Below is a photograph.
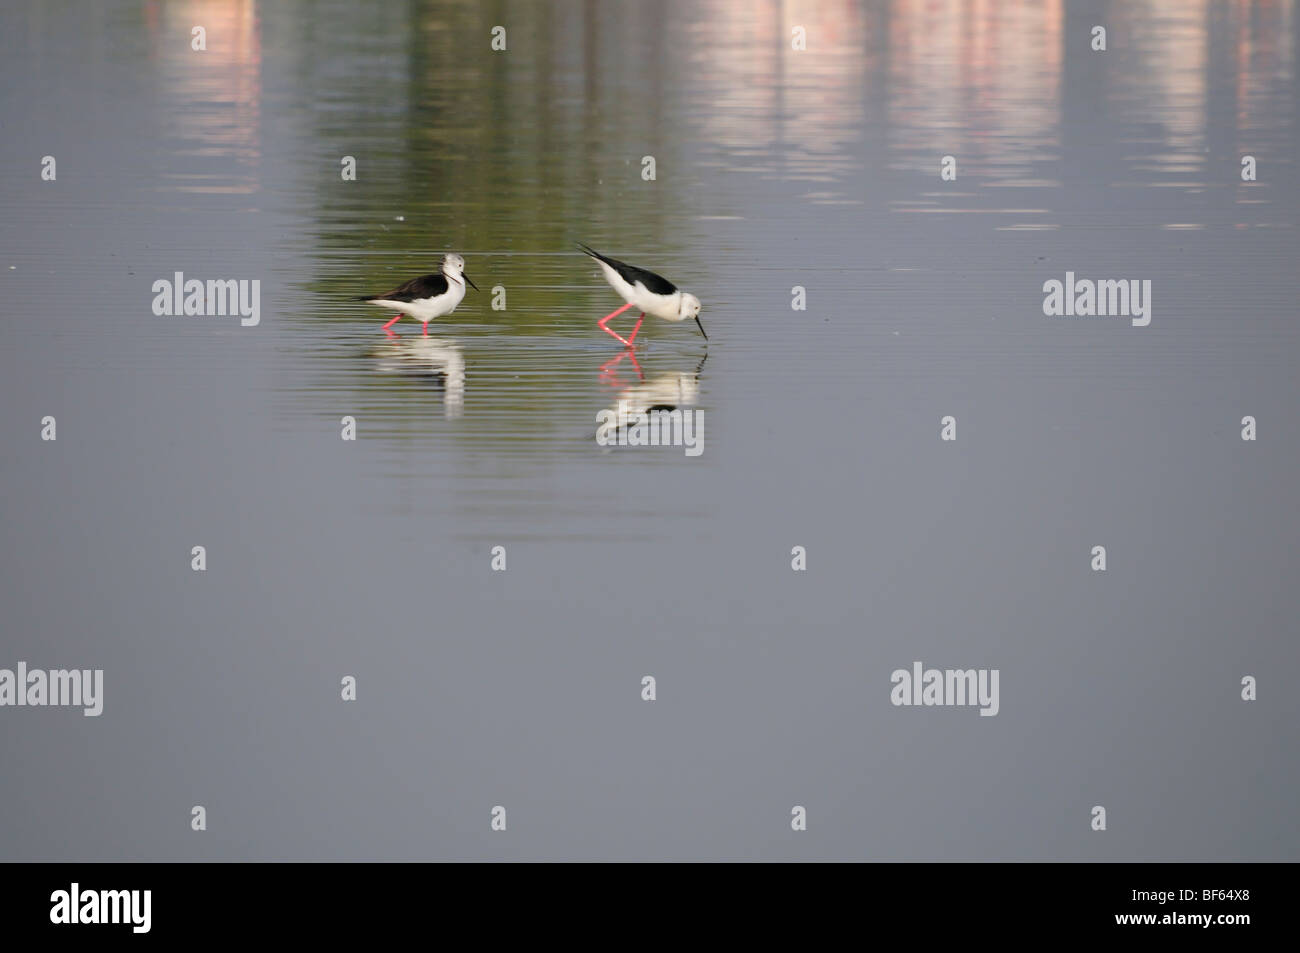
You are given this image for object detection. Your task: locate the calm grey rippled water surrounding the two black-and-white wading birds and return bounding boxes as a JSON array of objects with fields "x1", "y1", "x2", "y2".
[{"x1": 0, "y1": 0, "x2": 1300, "y2": 861}]
